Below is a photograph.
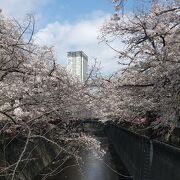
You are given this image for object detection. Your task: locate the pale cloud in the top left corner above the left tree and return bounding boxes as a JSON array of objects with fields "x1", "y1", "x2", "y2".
[{"x1": 0, "y1": 0, "x2": 50, "y2": 18}]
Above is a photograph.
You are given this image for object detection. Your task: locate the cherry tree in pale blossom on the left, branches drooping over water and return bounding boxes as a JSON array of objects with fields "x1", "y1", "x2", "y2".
[{"x1": 0, "y1": 15, "x2": 103, "y2": 180}]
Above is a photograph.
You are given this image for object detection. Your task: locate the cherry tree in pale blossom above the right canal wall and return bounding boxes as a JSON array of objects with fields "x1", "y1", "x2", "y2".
[{"x1": 97, "y1": 1, "x2": 180, "y2": 136}]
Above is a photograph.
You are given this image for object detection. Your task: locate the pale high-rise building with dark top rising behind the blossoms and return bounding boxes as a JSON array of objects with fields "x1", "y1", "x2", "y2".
[{"x1": 67, "y1": 51, "x2": 88, "y2": 82}]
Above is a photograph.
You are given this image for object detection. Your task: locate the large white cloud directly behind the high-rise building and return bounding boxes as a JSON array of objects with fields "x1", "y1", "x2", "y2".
[{"x1": 35, "y1": 12, "x2": 123, "y2": 73}]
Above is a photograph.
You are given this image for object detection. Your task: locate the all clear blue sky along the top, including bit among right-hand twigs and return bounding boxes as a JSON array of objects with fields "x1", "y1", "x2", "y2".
[{"x1": 33, "y1": 0, "x2": 140, "y2": 27}]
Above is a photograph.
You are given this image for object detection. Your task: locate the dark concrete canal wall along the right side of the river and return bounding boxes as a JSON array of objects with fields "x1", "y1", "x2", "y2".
[{"x1": 105, "y1": 124, "x2": 180, "y2": 180}]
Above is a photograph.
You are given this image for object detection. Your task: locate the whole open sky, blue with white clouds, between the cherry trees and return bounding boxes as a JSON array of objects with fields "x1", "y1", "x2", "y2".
[{"x1": 0, "y1": 0, "x2": 144, "y2": 74}]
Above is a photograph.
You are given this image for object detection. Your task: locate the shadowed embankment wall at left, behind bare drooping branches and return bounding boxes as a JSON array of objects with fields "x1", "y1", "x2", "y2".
[{"x1": 0, "y1": 137, "x2": 60, "y2": 180}]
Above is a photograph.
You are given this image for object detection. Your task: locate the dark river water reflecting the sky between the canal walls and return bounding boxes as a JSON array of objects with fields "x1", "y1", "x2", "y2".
[{"x1": 35, "y1": 125, "x2": 131, "y2": 180}]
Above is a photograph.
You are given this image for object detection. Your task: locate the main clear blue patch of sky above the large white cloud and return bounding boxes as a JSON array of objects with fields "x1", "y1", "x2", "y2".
[{"x1": 40, "y1": 0, "x2": 113, "y2": 22}]
